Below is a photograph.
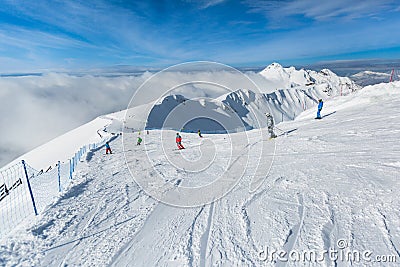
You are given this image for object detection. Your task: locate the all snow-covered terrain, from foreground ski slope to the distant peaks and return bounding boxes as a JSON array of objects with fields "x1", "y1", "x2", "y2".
[{"x1": 0, "y1": 63, "x2": 400, "y2": 266}]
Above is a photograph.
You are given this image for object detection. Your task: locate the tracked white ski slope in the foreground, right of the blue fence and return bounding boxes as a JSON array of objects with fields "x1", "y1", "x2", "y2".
[{"x1": 0, "y1": 82, "x2": 400, "y2": 266}]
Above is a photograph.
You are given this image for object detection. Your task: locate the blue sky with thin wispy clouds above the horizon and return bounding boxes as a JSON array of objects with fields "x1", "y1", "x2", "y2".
[{"x1": 0, "y1": 0, "x2": 400, "y2": 73}]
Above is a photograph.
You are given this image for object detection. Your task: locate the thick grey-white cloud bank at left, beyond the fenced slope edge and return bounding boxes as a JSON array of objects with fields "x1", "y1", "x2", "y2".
[{"x1": 0, "y1": 74, "x2": 140, "y2": 168}]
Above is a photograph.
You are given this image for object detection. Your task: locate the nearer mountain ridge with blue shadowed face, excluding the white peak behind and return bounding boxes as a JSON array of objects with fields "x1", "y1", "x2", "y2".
[{"x1": 120, "y1": 88, "x2": 326, "y2": 133}]
